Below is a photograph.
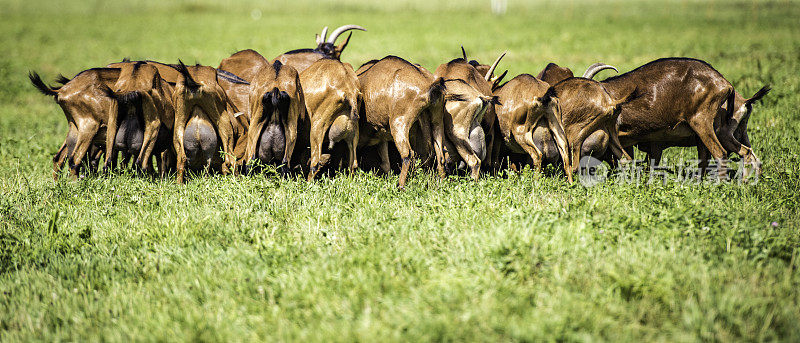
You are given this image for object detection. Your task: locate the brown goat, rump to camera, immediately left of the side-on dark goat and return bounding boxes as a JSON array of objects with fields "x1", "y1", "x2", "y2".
[{"x1": 542, "y1": 77, "x2": 632, "y2": 172}]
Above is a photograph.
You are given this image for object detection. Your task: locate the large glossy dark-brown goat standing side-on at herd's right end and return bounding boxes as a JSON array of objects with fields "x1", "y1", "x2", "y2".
[{"x1": 603, "y1": 58, "x2": 769, "y2": 175}]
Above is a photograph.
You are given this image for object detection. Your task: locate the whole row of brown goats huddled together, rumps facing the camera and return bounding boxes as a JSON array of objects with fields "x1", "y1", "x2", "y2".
[{"x1": 29, "y1": 25, "x2": 769, "y2": 188}]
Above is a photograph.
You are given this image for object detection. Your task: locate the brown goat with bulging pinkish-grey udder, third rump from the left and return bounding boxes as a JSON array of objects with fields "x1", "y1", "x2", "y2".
[{"x1": 173, "y1": 62, "x2": 240, "y2": 183}]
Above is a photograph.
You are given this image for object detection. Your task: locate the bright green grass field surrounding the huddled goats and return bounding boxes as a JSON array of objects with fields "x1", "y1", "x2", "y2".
[{"x1": 0, "y1": 0, "x2": 800, "y2": 341}]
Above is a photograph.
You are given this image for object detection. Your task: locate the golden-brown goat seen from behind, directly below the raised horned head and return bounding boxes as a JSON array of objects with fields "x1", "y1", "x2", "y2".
[{"x1": 300, "y1": 58, "x2": 361, "y2": 181}]
